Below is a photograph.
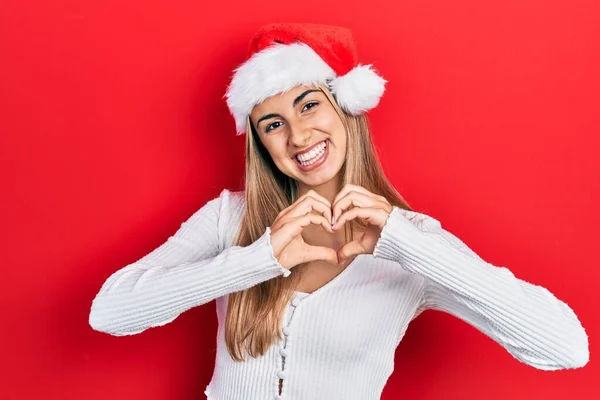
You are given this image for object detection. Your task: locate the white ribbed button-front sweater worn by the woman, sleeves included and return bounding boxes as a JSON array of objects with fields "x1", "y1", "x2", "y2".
[{"x1": 89, "y1": 189, "x2": 589, "y2": 400}]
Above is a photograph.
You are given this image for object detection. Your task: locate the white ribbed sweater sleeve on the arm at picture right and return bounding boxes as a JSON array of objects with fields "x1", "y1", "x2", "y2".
[{"x1": 373, "y1": 206, "x2": 589, "y2": 371}]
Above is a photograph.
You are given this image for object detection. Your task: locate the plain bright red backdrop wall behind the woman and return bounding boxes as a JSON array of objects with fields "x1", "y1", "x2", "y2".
[{"x1": 0, "y1": 0, "x2": 600, "y2": 400}]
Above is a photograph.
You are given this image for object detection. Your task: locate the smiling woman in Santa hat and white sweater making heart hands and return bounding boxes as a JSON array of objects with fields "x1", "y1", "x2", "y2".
[{"x1": 89, "y1": 24, "x2": 589, "y2": 400}]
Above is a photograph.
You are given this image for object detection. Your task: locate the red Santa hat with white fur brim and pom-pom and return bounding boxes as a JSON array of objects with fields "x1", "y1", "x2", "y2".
[{"x1": 224, "y1": 23, "x2": 387, "y2": 135}]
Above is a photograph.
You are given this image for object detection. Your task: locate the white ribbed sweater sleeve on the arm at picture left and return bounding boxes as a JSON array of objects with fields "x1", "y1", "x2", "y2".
[{"x1": 89, "y1": 190, "x2": 291, "y2": 336}]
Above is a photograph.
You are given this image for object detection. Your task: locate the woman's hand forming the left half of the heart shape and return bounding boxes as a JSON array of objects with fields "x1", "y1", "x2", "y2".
[{"x1": 271, "y1": 190, "x2": 338, "y2": 269}]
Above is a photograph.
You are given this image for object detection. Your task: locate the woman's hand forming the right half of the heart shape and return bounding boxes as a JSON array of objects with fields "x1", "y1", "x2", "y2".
[{"x1": 332, "y1": 184, "x2": 394, "y2": 264}]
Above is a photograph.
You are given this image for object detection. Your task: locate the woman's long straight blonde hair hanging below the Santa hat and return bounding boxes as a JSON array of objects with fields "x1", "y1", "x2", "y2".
[{"x1": 225, "y1": 85, "x2": 412, "y2": 361}]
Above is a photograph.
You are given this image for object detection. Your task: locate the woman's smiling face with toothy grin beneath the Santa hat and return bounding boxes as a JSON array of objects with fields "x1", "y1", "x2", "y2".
[{"x1": 250, "y1": 86, "x2": 346, "y2": 189}]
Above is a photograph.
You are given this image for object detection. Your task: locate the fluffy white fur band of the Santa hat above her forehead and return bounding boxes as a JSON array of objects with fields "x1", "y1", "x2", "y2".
[{"x1": 225, "y1": 42, "x2": 336, "y2": 135}]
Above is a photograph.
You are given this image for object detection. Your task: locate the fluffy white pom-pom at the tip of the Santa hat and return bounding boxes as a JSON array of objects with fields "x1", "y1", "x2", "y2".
[{"x1": 329, "y1": 64, "x2": 387, "y2": 115}]
